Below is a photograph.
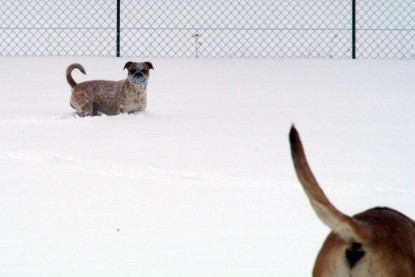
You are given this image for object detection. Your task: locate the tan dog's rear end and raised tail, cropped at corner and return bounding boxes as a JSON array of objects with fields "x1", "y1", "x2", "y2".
[{"x1": 290, "y1": 127, "x2": 415, "y2": 277}]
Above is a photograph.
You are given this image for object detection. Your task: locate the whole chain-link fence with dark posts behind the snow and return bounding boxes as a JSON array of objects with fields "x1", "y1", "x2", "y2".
[{"x1": 0, "y1": 0, "x2": 415, "y2": 59}]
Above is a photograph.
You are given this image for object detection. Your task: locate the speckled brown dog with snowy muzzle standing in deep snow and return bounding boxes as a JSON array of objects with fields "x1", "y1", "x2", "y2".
[{"x1": 66, "y1": 62, "x2": 154, "y2": 117}]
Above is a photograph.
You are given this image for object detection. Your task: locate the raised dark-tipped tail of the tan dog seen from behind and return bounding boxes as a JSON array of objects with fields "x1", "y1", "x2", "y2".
[{"x1": 290, "y1": 126, "x2": 373, "y2": 243}]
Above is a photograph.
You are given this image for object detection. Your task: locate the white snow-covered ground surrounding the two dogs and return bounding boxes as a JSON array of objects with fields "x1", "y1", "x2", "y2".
[{"x1": 0, "y1": 57, "x2": 415, "y2": 276}]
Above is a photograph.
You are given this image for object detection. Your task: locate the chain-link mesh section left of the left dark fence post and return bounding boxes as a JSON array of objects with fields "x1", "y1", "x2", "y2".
[{"x1": 0, "y1": 0, "x2": 117, "y2": 56}]
